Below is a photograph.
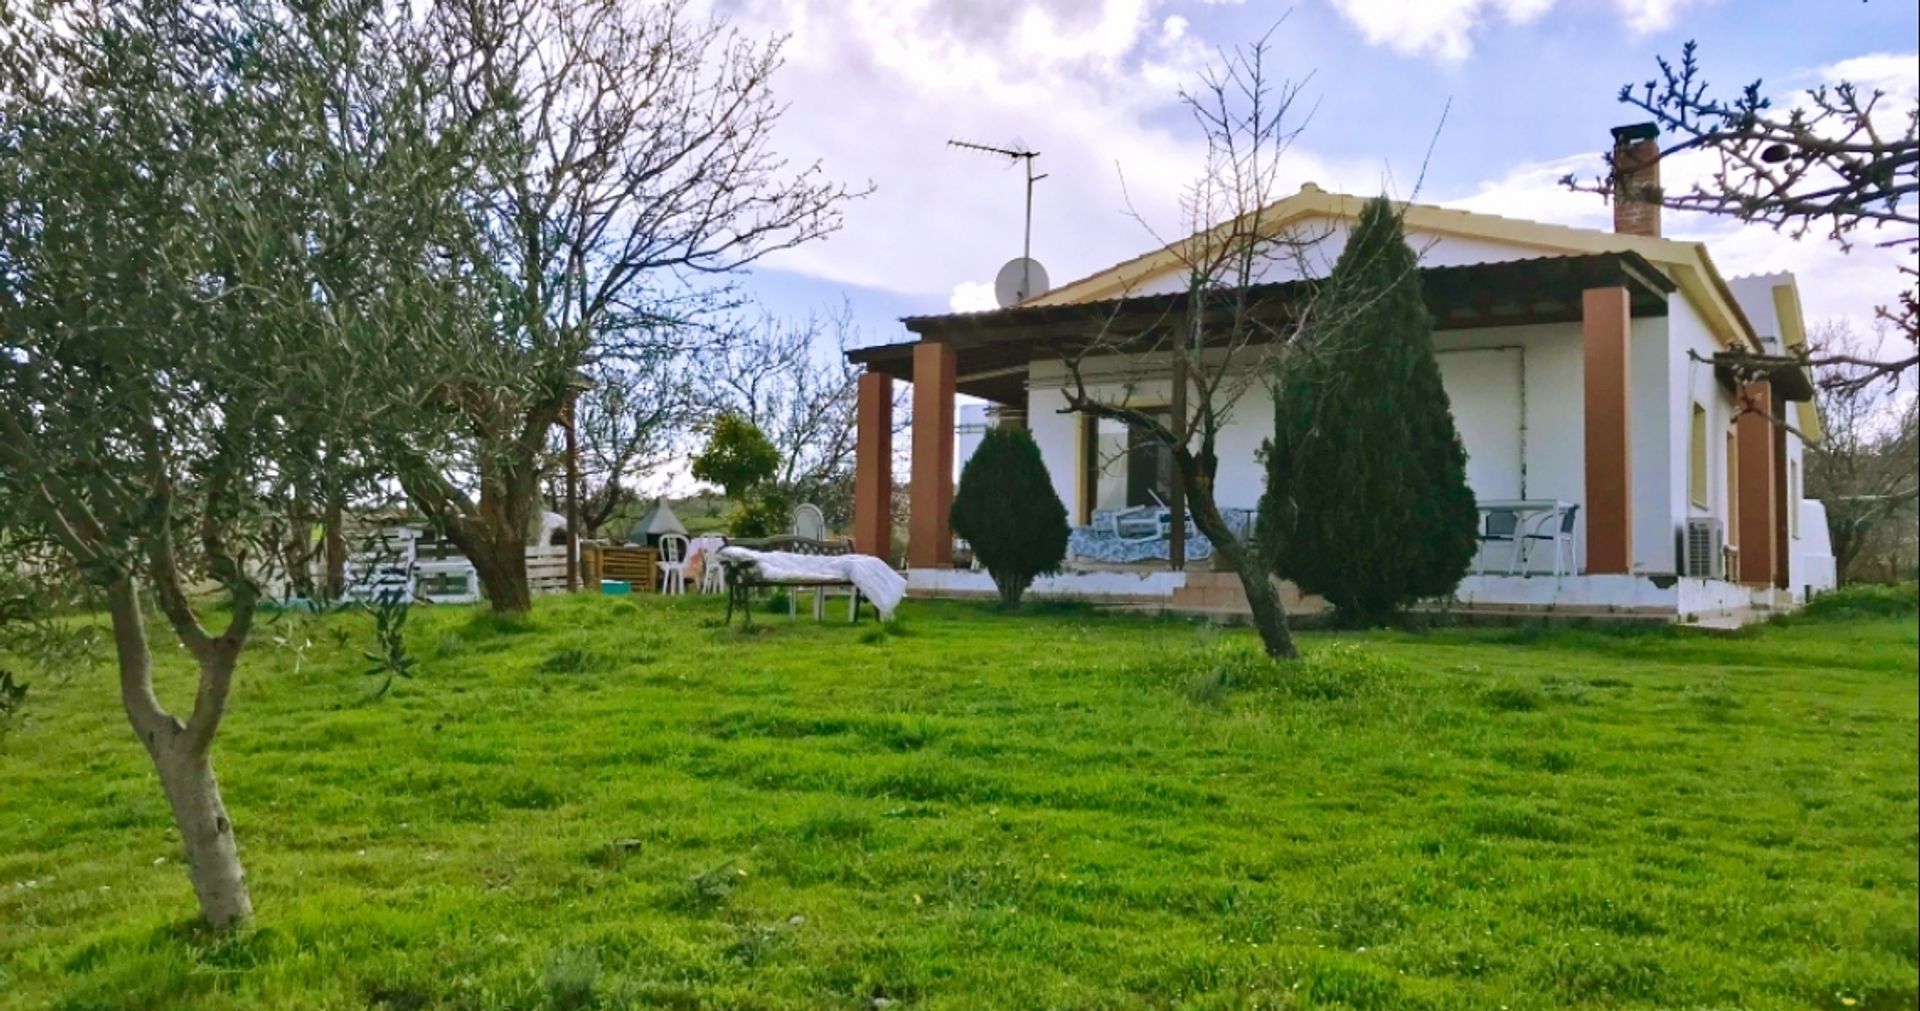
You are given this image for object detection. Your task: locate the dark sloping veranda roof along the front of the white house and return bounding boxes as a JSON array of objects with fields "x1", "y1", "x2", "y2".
[{"x1": 847, "y1": 251, "x2": 1674, "y2": 405}]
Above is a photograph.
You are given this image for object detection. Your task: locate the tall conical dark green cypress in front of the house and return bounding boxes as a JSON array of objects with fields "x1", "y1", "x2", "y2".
[{"x1": 1260, "y1": 198, "x2": 1478, "y2": 625}]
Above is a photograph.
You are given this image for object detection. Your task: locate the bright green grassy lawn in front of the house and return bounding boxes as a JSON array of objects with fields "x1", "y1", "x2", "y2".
[{"x1": 0, "y1": 597, "x2": 1920, "y2": 1011}]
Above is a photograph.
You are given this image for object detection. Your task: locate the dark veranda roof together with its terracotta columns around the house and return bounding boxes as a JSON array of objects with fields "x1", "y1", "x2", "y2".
[{"x1": 847, "y1": 251, "x2": 1784, "y2": 613}]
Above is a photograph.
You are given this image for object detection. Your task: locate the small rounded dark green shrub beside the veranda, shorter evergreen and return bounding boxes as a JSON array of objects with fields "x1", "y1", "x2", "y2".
[{"x1": 952, "y1": 428, "x2": 1068, "y2": 608}]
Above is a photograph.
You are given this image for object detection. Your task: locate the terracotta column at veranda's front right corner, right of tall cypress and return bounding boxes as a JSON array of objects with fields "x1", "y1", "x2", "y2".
[{"x1": 1580, "y1": 288, "x2": 1634, "y2": 574}]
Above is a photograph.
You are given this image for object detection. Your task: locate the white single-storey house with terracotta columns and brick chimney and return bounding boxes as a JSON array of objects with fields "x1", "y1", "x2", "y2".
[{"x1": 849, "y1": 127, "x2": 1834, "y2": 620}]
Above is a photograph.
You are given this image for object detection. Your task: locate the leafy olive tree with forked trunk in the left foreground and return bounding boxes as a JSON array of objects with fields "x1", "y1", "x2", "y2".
[{"x1": 0, "y1": 0, "x2": 460, "y2": 927}]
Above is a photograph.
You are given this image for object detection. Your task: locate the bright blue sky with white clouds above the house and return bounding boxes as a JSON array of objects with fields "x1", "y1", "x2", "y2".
[{"x1": 714, "y1": 0, "x2": 1920, "y2": 352}]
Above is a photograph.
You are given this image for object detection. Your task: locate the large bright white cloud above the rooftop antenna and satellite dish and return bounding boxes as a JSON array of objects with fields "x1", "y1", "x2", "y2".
[{"x1": 724, "y1": 0, "x2": 1379, "y2": 307}]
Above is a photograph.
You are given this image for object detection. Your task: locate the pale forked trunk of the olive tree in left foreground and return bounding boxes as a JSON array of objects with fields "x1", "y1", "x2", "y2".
[{"x1": 108, "y1": 577, "x2": 253, "y2": 929}]
